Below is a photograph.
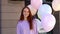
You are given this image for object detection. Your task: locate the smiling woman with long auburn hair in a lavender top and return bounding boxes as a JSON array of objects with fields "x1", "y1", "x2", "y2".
[{"x1": 17, "y1": 7, "x2": 38, "y2": 34}]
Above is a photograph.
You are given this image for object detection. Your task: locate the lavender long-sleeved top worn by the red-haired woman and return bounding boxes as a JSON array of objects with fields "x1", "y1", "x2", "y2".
[{"x1": 17, "y1": 20, "x2": 38, "y2": 34}]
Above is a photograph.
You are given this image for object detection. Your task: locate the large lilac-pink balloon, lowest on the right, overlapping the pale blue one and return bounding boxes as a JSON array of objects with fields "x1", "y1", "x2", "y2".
[{"x1": 41, "y1": 14, "x2": 56, "y2": 32}]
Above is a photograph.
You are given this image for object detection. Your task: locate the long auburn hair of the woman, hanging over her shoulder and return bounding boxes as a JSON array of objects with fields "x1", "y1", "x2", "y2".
[{"x1": 19, "y1": 7, "x2": 33, "y2": 30}]
